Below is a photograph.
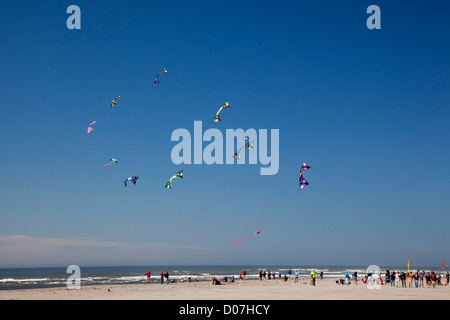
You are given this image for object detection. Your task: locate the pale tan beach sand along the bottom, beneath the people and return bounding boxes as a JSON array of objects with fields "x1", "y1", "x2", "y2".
[{"x1": 0, "y1": 279, "x2": 450, "y2": 300}]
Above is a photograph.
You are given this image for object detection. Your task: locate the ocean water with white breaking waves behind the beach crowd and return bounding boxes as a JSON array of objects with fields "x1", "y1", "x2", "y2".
[{"x1": 0, "y1": 265, "x2": 442, "y2": 290}]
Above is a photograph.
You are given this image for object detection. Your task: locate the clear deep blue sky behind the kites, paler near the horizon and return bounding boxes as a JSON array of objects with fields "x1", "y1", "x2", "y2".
[{"x1": 0, "y1": 0, "x2": 450, "y2": 267}]
